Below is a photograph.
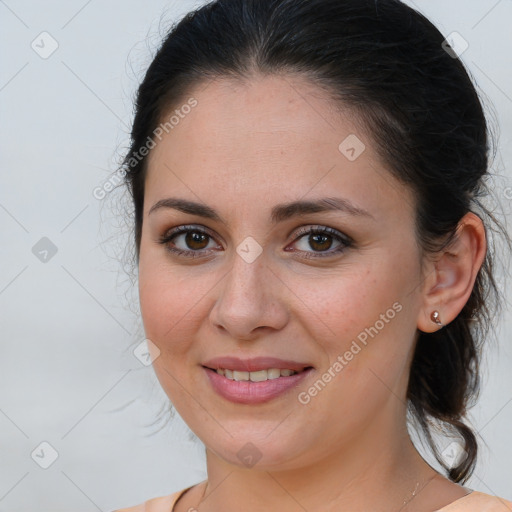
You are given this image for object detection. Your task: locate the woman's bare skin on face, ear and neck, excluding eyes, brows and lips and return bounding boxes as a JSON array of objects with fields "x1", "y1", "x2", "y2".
[{"x1": 135, "y1": 76, "x2": 486, "y2": 512}]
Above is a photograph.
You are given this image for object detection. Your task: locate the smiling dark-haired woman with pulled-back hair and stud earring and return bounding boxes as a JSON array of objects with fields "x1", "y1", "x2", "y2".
[{"x1": 114, "y1": 0, "x2": 512, "y2": 512}]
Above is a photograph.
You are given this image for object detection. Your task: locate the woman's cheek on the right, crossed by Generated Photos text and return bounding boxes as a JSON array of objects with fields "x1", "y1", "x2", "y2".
[{"x1": 303, "y1": 259, "x2": 415, "y2": 386}]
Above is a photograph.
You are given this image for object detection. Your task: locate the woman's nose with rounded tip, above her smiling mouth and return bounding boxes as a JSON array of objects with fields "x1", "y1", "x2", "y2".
[{"x1": 210, "y1": 248, "x2": 290, "y2": 341}]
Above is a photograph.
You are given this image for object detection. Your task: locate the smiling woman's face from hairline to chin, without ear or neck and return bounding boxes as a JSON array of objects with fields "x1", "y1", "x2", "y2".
[{"x1": 139, "y1": 77, "x2": 422, "y2": 468}]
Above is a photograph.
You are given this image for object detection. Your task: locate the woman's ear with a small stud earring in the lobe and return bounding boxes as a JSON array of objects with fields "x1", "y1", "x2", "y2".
[{"x1": 418, "y1": 212, "x2": 487, "y2": 332}]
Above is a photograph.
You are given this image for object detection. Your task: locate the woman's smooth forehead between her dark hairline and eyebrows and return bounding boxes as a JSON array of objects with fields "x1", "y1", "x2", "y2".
[{"x1": 146, "y1": 76, "x2": 412, "y2": 222}]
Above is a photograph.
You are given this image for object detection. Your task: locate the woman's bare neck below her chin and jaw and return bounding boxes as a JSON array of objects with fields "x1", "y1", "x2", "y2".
[{"x1": 201, "y1": 408, "x2": 436, "y2": 512}]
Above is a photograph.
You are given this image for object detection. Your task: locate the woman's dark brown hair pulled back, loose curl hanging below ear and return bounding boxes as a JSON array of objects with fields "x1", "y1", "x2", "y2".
[{"x1": 123, "y1": 0, "x2": 510, "y2": 482}]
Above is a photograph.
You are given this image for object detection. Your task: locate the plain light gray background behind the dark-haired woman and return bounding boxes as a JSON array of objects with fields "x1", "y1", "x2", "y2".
[{"x1": 0, "y1": 0, "x2": 512, "y2": 512}]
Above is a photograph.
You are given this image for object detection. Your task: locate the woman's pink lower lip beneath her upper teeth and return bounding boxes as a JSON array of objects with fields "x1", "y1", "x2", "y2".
[{"x1": 203, "y1": 366, "x2": 313, "y2": 404}]
